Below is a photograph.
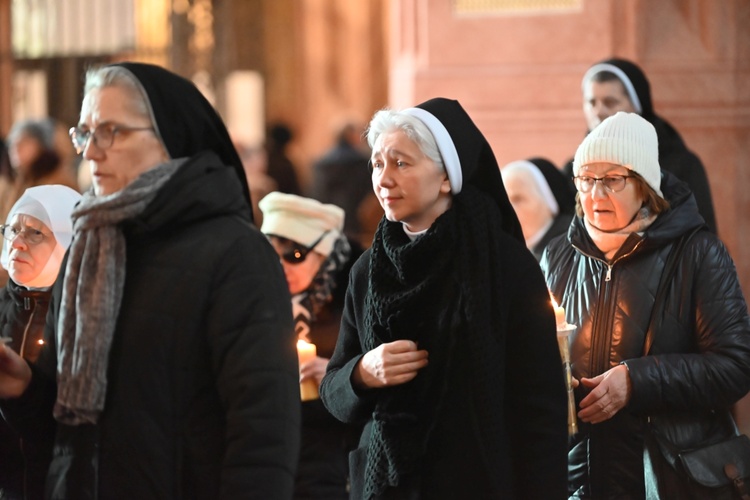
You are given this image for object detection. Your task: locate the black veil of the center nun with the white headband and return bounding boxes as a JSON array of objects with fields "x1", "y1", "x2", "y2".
[{"x1": 415, "y1": 97, "x2": 524, "y2": 242}]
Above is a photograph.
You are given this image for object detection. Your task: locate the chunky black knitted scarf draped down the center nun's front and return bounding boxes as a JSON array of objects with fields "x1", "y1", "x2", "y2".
[{"x1": 364, "y1": 186, "x2": 504, "y2": 499}]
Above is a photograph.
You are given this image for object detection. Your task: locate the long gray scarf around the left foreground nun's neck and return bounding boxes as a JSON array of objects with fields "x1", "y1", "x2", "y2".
[{"x1": 53, "y1": 158, "x2": 185, "y2": 425}]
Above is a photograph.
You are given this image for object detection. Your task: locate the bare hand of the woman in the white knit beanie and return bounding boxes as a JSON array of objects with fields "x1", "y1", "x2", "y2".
[{"x1": 578, "y1": 365, "x2": 630, "y2": 424}]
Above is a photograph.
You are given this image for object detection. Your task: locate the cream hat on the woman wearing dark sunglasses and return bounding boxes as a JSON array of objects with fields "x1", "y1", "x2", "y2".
[{"x1": 258, "y1": 191, "x2": 344, "y2": 257}]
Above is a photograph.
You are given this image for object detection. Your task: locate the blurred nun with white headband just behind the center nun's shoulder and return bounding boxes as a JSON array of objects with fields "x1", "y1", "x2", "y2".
[{"x1": 500, "y1": 158, "x2": 575, "y2": 260}]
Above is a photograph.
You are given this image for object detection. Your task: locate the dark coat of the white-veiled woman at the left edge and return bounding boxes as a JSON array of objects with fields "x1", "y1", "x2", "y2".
[{"x1": 0, "y1": 280, "x2": 52, "y2": 500}]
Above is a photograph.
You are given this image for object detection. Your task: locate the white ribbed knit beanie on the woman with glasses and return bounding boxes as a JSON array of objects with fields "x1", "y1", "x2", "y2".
[{"x1": 573, "y1": 111, "x2": 664, "y2": 198}]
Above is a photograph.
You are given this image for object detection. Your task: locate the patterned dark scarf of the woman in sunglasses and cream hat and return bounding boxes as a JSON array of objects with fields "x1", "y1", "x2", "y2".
[{"x1": 292, "y1": 234, "x2": 352, "y2": 342}]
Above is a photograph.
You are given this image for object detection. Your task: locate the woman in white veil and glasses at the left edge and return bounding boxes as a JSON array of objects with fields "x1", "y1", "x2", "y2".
[{"x1": 0, "y1": 185, "x2": 81, "y2": 500}]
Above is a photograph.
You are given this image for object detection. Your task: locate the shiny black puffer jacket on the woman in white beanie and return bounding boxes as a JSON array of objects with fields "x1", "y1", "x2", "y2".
[{"x1": 541, "y1": 172, "x2": 750, "y2": 499}]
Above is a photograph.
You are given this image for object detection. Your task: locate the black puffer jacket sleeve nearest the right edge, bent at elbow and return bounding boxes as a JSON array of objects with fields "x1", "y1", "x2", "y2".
[{"x1": 625, "y1": 233, "x2": 750, "y2": 414}]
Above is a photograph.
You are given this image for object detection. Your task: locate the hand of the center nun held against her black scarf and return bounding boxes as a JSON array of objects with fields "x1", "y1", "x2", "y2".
[{"x1": 353, "y1": 340, "x2": 428, "y2": 389}]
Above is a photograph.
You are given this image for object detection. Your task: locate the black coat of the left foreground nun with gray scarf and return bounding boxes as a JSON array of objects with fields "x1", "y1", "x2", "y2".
[{"x1": 2, "y1": 153, "x2": 299, "y2": 500}]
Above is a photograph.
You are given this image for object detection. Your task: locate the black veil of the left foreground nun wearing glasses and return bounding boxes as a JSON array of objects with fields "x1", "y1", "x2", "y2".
[{"x1": 112, "y1": 62, "x2": 253, "y2": 218}]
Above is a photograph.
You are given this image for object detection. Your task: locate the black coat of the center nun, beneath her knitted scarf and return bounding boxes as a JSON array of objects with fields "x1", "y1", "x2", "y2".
[{"x1": 321, "y1": 233, "x2": 564, "y2": 500}]
